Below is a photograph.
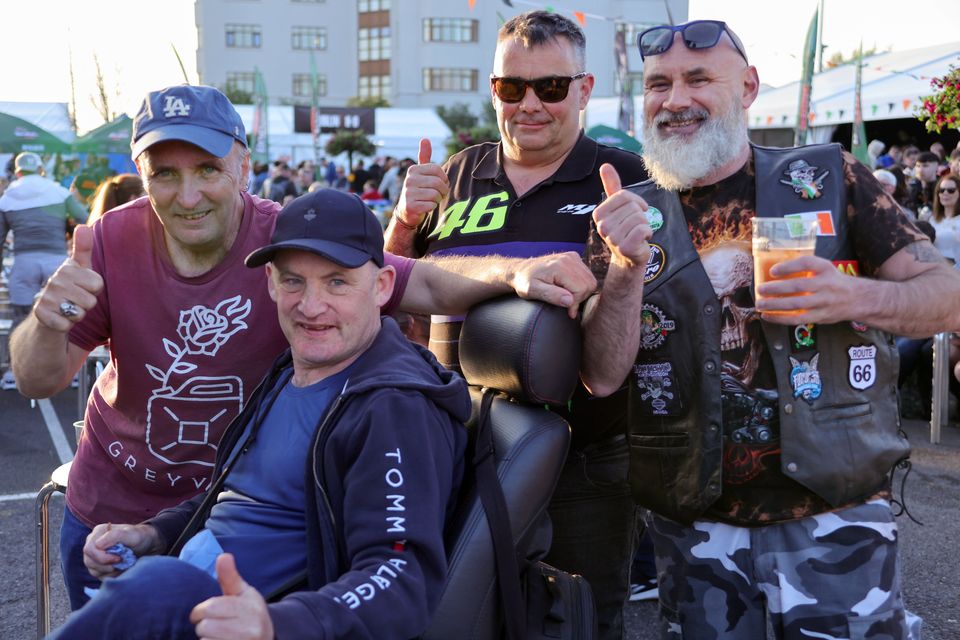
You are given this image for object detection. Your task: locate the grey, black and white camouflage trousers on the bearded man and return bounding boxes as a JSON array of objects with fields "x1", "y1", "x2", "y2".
[{"x1": 646, "y1": 500, "x2": 921, "y2": 640}]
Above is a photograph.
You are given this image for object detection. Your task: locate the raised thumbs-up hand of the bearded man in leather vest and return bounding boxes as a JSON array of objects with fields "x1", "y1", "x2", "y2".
[{"x1": 593, "y1": 164, "x2": 653, "y2": 269}]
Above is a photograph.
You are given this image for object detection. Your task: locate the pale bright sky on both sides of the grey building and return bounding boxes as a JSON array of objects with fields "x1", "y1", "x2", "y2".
[{"x1": 0, "y1": 0, "x2": 960, "y2": 133}]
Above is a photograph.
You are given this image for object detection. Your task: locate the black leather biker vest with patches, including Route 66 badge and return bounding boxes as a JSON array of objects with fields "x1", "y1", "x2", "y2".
[{"x1": 628, "y1": 144, "x2": 910, "y2": 524}]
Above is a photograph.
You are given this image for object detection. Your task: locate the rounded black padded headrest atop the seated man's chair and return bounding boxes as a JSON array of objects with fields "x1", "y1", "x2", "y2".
[{"x1": 460, "y1": 296, "x2": 580, "y2": 405}]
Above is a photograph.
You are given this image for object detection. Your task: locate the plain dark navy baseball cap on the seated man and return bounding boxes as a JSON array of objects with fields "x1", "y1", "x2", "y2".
[{"x1": 246, "y1": 189, "x2": 383, "y2": 269}]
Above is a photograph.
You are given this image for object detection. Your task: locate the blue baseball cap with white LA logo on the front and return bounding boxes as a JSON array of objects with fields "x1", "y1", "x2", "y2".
[{"x1": 130, "y1": 84, "x2": 247, "y2": 160}]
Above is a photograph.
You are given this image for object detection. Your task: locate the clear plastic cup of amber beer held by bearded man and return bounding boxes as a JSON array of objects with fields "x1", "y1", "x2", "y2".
[{"x1": 753, "y1": 218, "x2": 819, "y2": 316}]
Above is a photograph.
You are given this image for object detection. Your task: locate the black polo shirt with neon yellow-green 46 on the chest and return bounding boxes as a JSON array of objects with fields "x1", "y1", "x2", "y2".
[{"x1": 414, "y1": 132, "x2": 647, "y2": 447}]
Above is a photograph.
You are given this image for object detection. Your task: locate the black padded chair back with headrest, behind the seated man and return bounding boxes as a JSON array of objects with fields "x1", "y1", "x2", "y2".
[{"x1": 424, "y1": 297, "x2": 580, "y2": 640}]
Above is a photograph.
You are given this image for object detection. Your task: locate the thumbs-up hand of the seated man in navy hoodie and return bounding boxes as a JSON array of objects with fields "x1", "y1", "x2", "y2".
[{"x1": 190, "y1": 553, "x2": 273, "y2": 640}]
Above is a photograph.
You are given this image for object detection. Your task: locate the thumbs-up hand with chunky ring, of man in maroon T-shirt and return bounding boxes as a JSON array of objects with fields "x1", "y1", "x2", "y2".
[{"x1": 33, "y1": 225, "x2": 103, "y2": 333}]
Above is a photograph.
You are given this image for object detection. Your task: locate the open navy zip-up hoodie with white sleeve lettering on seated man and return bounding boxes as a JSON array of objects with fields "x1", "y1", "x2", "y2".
[{"x1": 147, "y1": 318, "x2": 470, "y2": 640}]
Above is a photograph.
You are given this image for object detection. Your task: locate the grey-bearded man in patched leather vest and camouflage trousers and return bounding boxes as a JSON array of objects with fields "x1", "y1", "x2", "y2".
[{"x1": 582, "y1": 20, "x2": 960, "y2": 640}]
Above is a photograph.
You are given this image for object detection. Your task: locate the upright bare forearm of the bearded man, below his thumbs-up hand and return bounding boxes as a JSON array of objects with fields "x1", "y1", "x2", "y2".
[{"x1": 580, "y1": 262, "x2": 644, "y2": 397}]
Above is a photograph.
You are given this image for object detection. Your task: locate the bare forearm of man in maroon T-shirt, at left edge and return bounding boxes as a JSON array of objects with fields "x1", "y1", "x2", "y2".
[{"x1": 10, "y1": 314, "x2": 81, "y2": 398}]
